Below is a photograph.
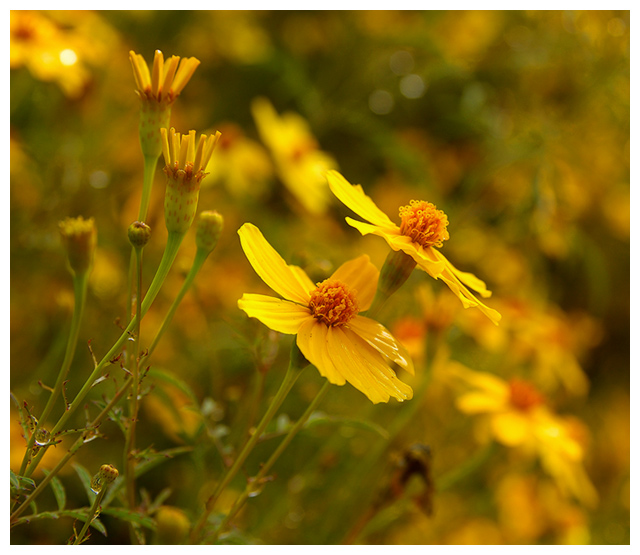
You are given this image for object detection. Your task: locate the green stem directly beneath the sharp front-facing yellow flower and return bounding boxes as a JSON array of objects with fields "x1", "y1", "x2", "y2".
[{"x1": 191, "y1": 341, "x2": 309, "y2": 543}]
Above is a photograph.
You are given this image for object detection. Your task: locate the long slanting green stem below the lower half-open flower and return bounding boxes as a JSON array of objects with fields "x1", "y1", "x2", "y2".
[{"x1": 24, "y1": 233, "x2": 184, "y2": 476}]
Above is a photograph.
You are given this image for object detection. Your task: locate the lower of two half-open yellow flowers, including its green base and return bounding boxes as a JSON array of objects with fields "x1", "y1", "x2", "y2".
[{"x1": 160, "y1": 127, "x2": 220, "y2": 234}]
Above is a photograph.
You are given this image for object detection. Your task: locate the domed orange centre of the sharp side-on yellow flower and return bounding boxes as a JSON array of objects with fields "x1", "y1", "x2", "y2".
[{"x1": 400, "y1": 200, "x2": 449, "y2": 248}]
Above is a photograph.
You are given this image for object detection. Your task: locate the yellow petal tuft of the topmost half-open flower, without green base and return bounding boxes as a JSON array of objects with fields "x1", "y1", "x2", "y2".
[{"x1": 129, "y1": 50, "x2": 200, "y2": 104}]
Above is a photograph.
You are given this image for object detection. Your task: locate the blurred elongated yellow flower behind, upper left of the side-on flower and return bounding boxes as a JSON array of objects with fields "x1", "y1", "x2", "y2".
[{"x1": 251, "y1": 98, "x2": 337, "y2": 214}]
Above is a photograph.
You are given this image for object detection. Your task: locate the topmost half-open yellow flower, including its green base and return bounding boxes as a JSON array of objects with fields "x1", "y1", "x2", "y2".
[{"x1": 129, "y1": 50, "x2": 200, "y2": 158}]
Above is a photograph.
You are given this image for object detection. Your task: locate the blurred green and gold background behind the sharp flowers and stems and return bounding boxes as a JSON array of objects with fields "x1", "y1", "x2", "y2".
[{"x1": 10, "y1": 11, "x2": 630, "y2": 544}]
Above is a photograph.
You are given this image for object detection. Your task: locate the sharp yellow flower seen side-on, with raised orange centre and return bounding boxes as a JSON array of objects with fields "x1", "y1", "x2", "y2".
[{"x1": 327, "y1": 170, "x2": 501, "y2": 324}]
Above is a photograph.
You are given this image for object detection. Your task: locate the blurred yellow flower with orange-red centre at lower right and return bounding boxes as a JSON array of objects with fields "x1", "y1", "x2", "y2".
[{"x1": 447, "y1": 362, "x2": 598, "y2": 506}]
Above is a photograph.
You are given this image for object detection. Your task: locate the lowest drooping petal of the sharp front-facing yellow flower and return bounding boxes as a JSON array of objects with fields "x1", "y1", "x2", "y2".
[{"x1": 327, "y1": 326, "x2": 413, "y2": 403}]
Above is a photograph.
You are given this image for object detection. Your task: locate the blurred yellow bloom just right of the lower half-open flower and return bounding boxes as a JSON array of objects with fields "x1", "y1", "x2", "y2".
[{"x1": 207, "y1": 124, "x2": 273, "y2": 198}]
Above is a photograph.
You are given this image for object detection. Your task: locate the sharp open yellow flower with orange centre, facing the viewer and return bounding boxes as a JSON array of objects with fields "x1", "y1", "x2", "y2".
[{"x1": 238, "y1": 223, "x2": 414, "y2": 403}]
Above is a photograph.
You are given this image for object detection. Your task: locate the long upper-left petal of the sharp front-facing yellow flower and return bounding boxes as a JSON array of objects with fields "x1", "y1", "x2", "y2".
[{"x1": 238, "y1": 223, "x2": 310, "y2": 306}]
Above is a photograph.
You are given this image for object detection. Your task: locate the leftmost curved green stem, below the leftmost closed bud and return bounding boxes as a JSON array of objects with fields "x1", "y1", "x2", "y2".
[{"x1": 20, "y1": 272, "x2": 89, "y2": 475}]
